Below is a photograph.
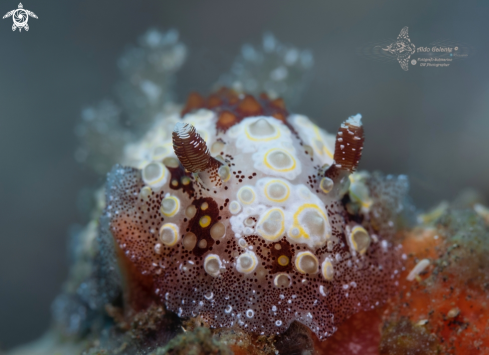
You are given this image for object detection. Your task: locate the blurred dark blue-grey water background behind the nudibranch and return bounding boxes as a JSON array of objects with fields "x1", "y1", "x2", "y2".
[{"x1": 0, "y1": 0, "x2": 489, "y2": 349}]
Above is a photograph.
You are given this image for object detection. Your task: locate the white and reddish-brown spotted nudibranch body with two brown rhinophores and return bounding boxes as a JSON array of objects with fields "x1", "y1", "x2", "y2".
[{"x1": 105, "y1": 89, "x2": 399, "y2": 339}]
